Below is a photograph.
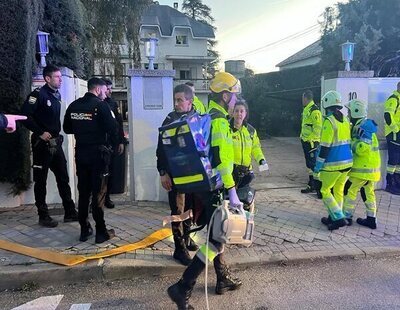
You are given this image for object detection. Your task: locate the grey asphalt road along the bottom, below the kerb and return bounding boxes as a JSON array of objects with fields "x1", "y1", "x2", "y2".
[{"x1": 0, "y1": 257, "x2": 400, "y2": 310}]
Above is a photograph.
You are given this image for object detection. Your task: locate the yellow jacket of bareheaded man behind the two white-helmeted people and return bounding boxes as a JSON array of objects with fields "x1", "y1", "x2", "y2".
[{"x1": 300, "y1": 100, "x2": 322, "y2": 142}]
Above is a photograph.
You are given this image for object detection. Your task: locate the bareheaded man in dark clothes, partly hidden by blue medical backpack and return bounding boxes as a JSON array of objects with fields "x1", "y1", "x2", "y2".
[{"x1": 156, "y1": 84, "x2": 198, "y2": 266}]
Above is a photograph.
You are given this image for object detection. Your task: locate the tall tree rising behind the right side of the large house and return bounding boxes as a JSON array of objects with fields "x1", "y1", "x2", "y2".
[{"x1": 182, "y1": 0, "x2": 219, "y2": 76}]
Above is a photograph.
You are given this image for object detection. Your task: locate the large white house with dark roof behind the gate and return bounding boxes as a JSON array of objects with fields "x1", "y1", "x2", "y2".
[{"x1": 95, "y1": 4, "x2": 215, "y2": 117}]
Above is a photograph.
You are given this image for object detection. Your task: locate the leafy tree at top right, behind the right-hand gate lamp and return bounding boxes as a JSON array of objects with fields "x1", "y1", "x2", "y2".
[{"x1": 321, "y1": 0, "x2": 400, "y2": 76}]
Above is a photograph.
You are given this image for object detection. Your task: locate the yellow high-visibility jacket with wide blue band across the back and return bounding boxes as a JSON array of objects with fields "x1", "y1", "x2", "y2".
[{"x1": 317, "y1": 115, "x2": 353, "y2": 171}]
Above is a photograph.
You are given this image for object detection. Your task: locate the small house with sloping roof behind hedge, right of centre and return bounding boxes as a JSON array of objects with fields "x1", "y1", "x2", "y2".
[{"x1": 276, "y1": 40, "x2": 322, "y2": 71}]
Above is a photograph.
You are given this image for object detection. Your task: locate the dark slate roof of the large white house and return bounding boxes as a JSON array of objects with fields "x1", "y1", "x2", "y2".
[{"x1": 141, "y1": 4, "x2": 215, "y2": 38}]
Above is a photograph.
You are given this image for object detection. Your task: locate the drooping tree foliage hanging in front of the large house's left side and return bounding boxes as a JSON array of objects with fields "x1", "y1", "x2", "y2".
[{"x1": 81, "y1": 0, "x2": 153, "y2": 76}]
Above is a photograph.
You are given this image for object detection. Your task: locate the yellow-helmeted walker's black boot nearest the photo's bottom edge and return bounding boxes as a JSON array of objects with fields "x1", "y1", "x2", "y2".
[{"x1": 167, "y1": 256, "x2": 205, "y2": 310}]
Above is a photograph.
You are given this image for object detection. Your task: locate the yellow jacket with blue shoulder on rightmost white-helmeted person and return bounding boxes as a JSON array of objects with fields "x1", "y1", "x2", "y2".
[{"x1": 349, "y1": 118, "x2": 381, "y2": 182}]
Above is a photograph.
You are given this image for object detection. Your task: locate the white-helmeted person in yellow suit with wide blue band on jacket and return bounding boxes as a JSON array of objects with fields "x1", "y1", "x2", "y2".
[{"x1": 314, "y1": 91, "x2": 353, "y2": 230}]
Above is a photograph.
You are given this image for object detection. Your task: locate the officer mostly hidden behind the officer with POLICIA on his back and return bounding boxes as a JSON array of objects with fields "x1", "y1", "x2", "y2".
[{"x1": 103, "y1": 79, "x2": 125, "y2": 209}]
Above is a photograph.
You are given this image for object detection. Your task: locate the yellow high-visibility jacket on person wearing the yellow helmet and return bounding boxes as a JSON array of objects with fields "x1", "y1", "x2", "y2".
[{"x1": 207, "y1": 100, "x2": 235, "y2": 189}]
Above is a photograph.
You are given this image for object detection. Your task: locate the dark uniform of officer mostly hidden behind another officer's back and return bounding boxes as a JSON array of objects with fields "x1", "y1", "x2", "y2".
[{"x1": 104, "y1": 97, "x2": 126, "y2": 203}]
